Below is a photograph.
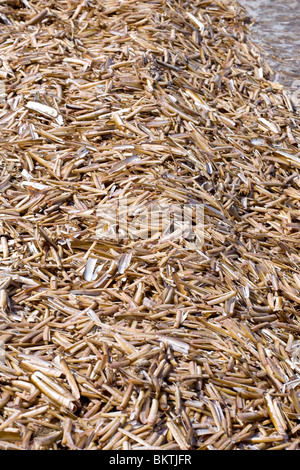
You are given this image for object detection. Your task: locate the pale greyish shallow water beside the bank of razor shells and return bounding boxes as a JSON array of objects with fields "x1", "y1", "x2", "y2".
[{"x1": 239, "y1": 0, "x2": 300, "y2": 92}]
